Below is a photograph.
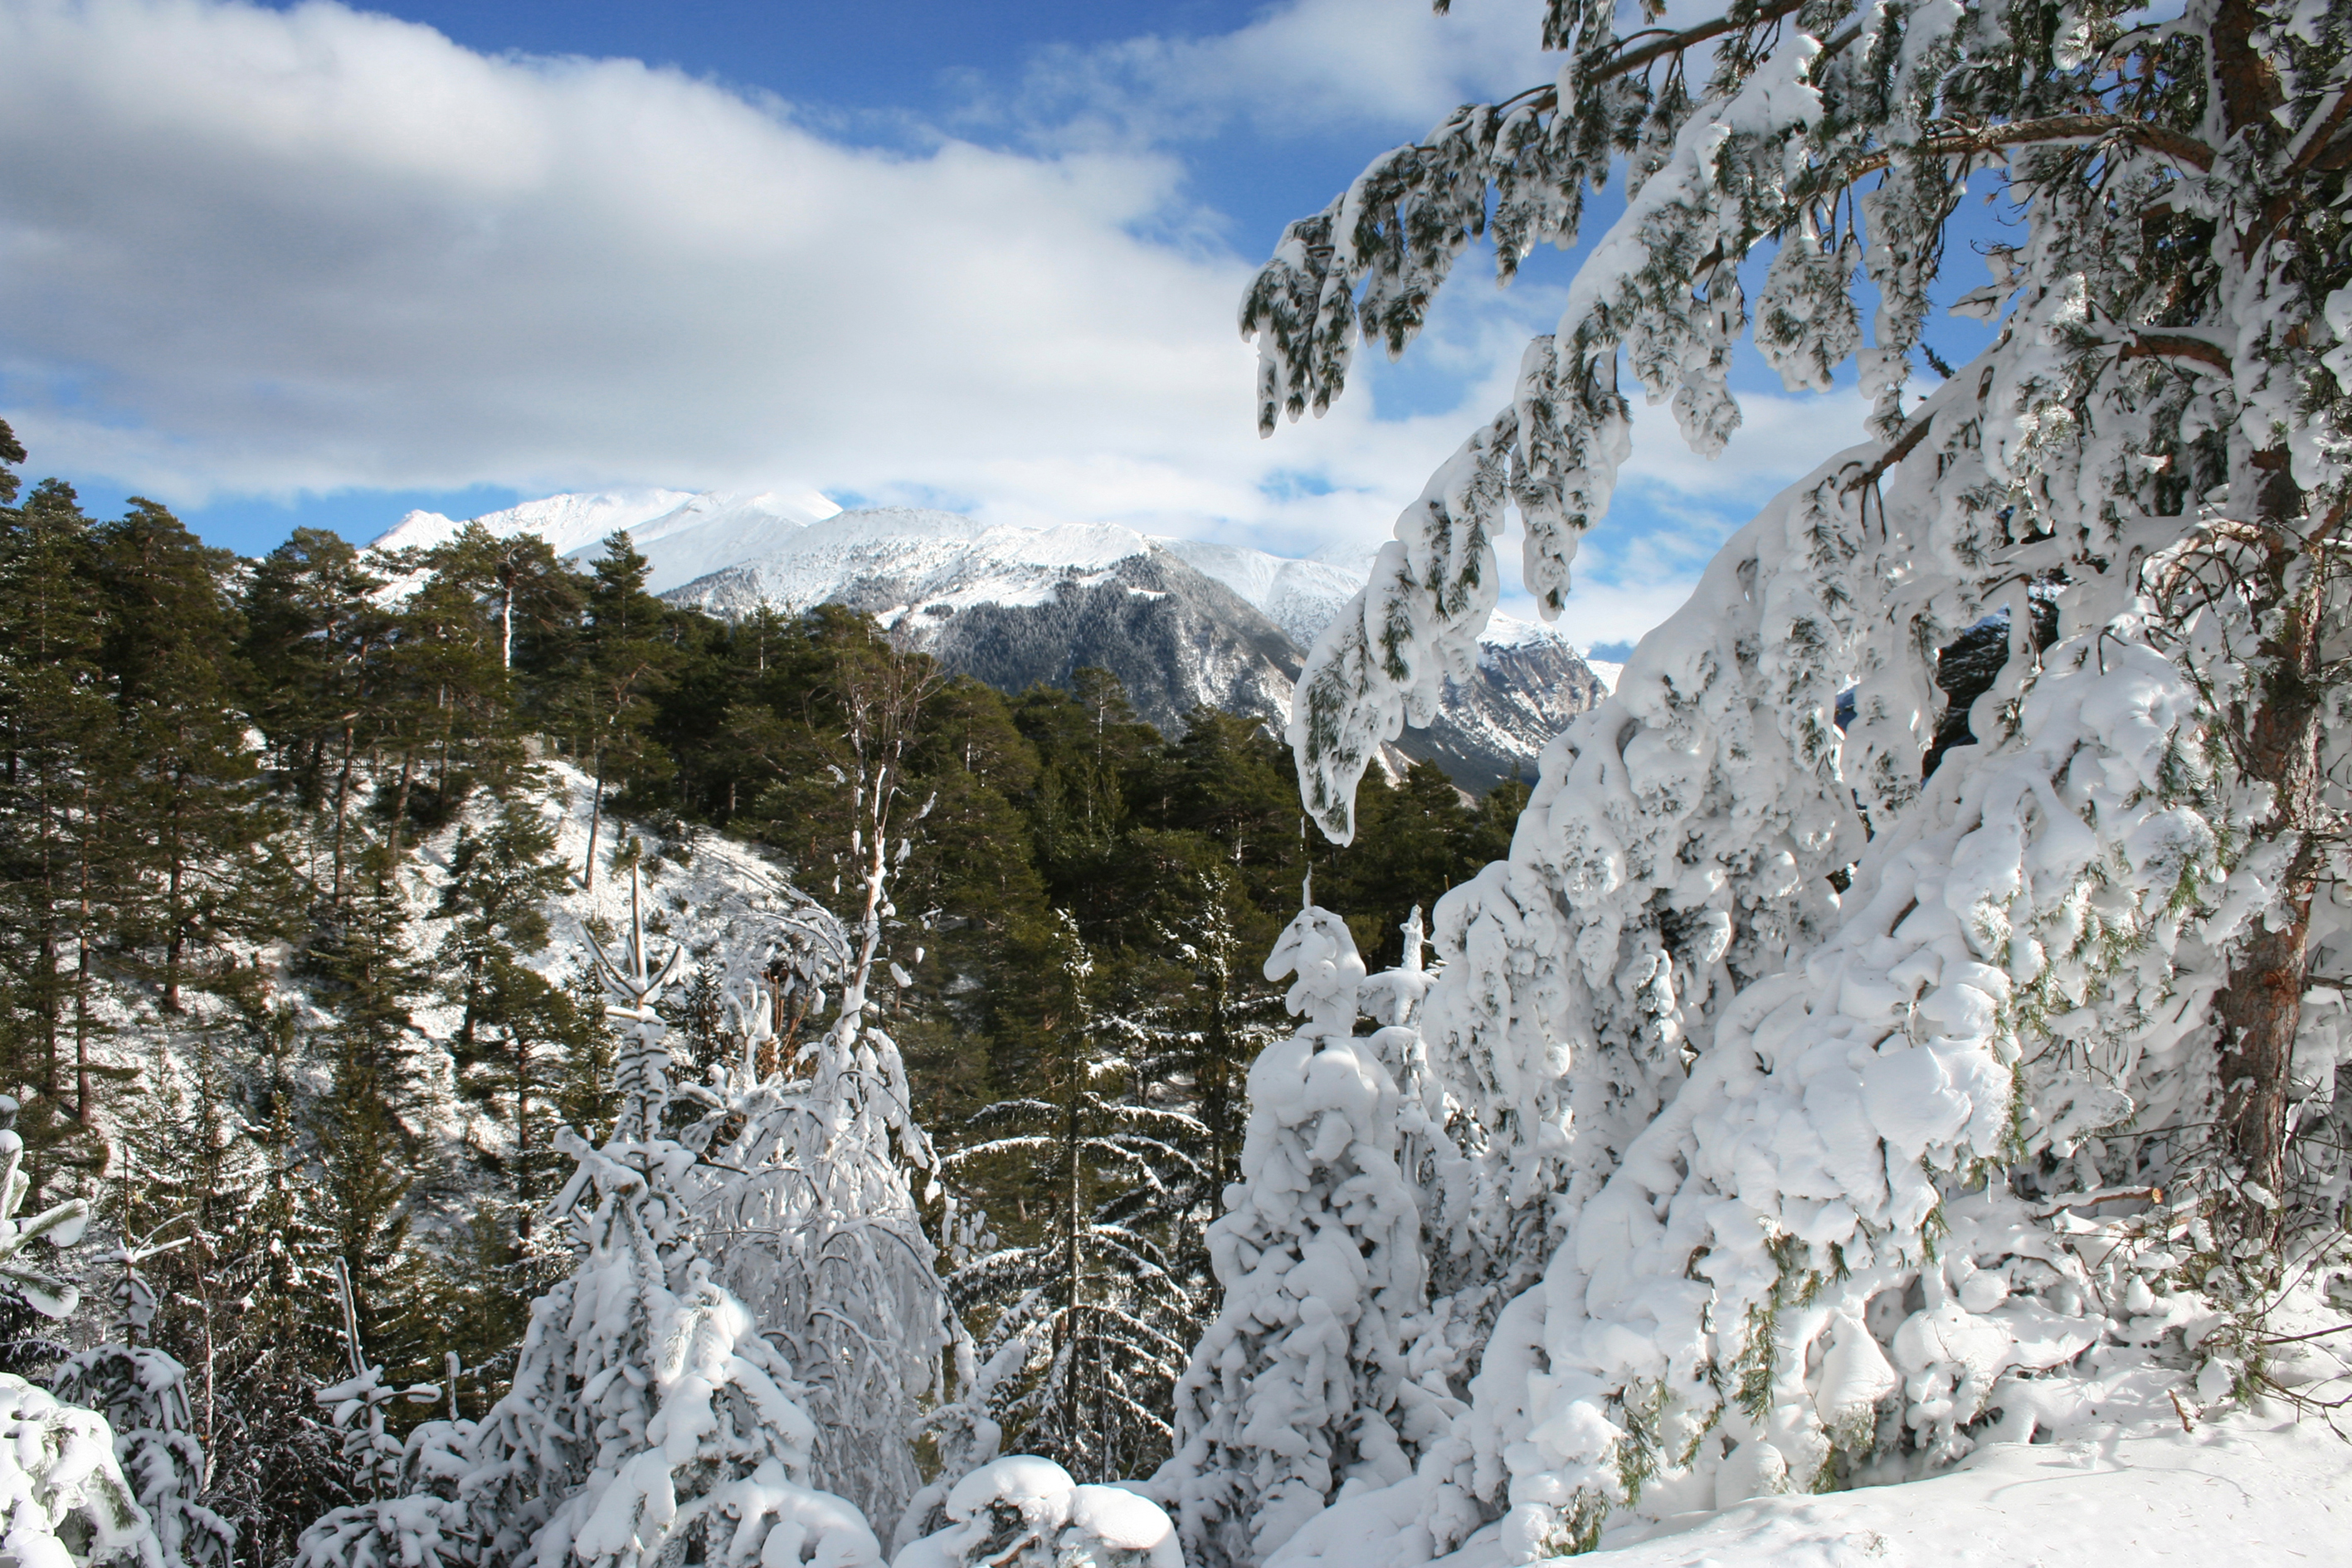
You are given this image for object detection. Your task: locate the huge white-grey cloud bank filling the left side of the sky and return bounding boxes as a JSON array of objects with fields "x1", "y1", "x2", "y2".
[{"x1": 0, "y1": 0, "x2": 1444, "y2": 522}]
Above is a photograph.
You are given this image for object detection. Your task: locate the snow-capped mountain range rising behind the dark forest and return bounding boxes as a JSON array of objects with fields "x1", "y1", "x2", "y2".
[{"x1": 377, "y1": 489, "x2": 1604, "y2": 790}]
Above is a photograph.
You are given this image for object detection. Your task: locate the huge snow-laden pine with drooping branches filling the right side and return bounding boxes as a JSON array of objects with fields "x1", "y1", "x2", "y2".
[{"x1": 1242, "y1": 0, "x2": 2352, "y2": 1563}]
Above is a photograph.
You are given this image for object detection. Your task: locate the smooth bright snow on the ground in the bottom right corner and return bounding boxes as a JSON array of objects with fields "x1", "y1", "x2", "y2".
[{"x1": 1542, "y1": 1415, "x2": 2352, "y2": 1568}]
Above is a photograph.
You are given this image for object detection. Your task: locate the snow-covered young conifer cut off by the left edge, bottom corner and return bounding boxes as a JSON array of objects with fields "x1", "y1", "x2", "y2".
[{"x1": 0, "y1": 1095, "x2": 164, "y2": 1568}]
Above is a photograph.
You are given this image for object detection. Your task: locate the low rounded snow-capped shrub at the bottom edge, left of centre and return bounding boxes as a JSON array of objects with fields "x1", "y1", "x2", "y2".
[{"x1": 891, "y1": 1453, "x2": 1183, "y2": 1568}]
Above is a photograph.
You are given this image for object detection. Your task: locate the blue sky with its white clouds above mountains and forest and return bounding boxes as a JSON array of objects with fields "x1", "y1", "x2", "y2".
[{"x1": 0, "y1": 0, "x2": 1971, "y2": 644}]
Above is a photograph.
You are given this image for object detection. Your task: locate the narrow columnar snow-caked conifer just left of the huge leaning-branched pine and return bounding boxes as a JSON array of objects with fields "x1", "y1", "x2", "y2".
[{"x1": 1152, "y1": 905, "x2": 1434, "y2": 1568}]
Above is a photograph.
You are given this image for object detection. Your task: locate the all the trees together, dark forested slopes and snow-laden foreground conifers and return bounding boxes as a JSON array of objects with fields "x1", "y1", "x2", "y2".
[{"x1": 13, "y1": 0, "x2": 2352, "y2": 1568}]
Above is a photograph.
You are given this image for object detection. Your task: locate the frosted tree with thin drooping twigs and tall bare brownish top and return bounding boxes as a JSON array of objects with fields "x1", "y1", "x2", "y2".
[{"x1": 701, "y1": 658, "x2": 950, "y2": 1521}]
